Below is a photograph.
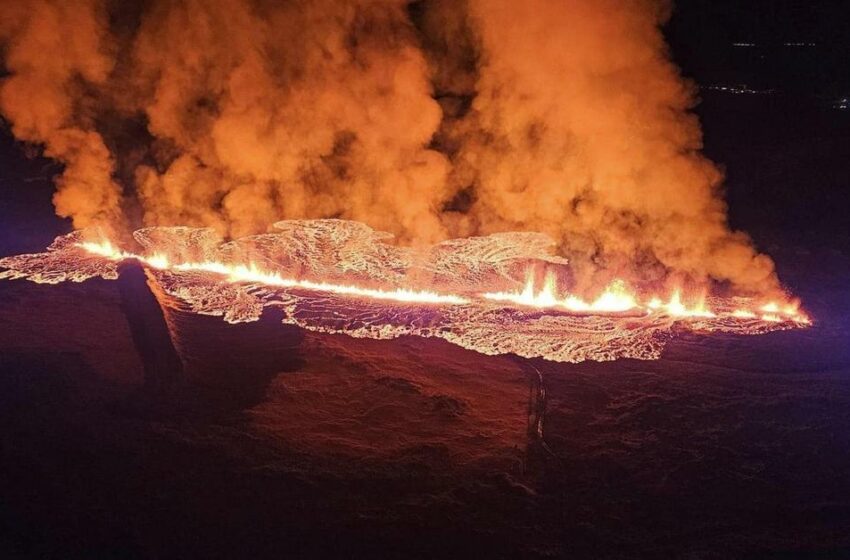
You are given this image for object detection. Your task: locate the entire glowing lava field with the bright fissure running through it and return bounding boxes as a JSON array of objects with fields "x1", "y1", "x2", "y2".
[{"x1": 0, "y1": 220, "x2": 810, "y2": 362}]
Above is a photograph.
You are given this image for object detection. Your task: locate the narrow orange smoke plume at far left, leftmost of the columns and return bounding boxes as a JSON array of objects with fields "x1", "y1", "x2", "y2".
[{"x1": 0, "y1": 0, "x2": 121, "y2": 227}]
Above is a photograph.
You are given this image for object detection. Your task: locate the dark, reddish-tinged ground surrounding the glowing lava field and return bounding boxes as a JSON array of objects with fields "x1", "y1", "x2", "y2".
[{"x1": 0, "y1": 6, "x2": 850, "y2": 558}]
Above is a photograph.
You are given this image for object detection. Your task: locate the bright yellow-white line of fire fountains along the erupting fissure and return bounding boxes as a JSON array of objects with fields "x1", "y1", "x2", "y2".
[{"x1": 77, "y1": 241, "x2": 811, "y2": 326}]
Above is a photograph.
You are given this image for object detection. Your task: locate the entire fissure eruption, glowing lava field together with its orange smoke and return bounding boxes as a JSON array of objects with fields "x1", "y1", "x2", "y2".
[{"x1": 0, "y1": 0, "x2": 809, "y2": 361}]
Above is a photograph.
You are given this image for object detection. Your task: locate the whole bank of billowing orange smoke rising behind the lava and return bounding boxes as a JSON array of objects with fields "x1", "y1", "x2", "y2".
[{"x1": 0, "y1": 0, "x2": 777, "y2": 291}]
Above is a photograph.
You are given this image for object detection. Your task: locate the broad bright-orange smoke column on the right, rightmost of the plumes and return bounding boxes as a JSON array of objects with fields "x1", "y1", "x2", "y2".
[{"x1": 438, "y1": 0, "x2": 773, "y2": 296}]
